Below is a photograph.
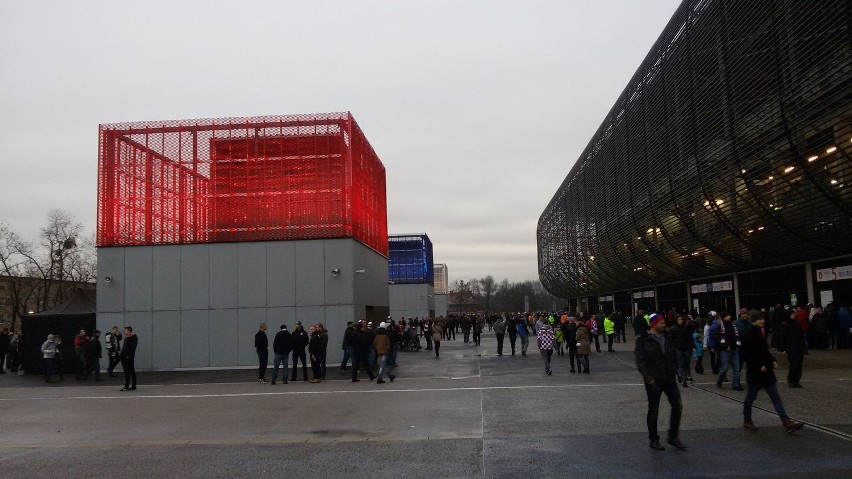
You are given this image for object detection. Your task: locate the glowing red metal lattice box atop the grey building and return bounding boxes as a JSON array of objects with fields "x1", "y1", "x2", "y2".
[{"x1": 97, "y1": 112, "x2": 388, "y2": 256}]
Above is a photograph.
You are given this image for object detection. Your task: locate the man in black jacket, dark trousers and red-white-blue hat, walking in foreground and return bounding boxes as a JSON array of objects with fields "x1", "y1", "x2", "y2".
[{"x1": 634, "y1": 314, "x2": 686, "y2": 451}]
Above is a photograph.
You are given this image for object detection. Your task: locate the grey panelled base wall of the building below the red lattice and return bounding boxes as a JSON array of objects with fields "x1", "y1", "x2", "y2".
[{"x1": 97, "y1": 239, "x2": 388, "y2": 369}]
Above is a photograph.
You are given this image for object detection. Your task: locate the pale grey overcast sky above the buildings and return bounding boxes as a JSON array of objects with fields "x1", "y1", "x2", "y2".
[{"x1": 0, "y1": 0, "x2": 680, "y2": 281}]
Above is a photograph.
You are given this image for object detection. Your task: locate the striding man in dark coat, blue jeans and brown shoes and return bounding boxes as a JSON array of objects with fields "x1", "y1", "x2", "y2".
[{"x1": 743, "y1": 311, "x2": 802, "y2": 434}]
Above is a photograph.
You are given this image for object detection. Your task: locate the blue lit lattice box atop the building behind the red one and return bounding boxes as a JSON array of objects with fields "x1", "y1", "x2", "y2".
[{"x1": 388, "y1": 233, "x2": 435, "y2": 285}]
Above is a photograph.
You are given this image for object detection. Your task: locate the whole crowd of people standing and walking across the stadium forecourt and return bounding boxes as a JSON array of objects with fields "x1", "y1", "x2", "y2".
[{"x1": 5, "y1": 305, "x2": 852, "y2": 450}]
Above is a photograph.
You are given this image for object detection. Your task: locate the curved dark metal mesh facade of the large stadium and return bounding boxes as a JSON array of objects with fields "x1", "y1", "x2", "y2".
[{"x1": 537, "y1": 0, "x2": 852, "y2": 297}]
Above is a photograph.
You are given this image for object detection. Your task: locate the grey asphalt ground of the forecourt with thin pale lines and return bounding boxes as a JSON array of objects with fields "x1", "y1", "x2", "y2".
[{"x1": 0, "y1": 332, "x2": 852, "y2": 479}]
